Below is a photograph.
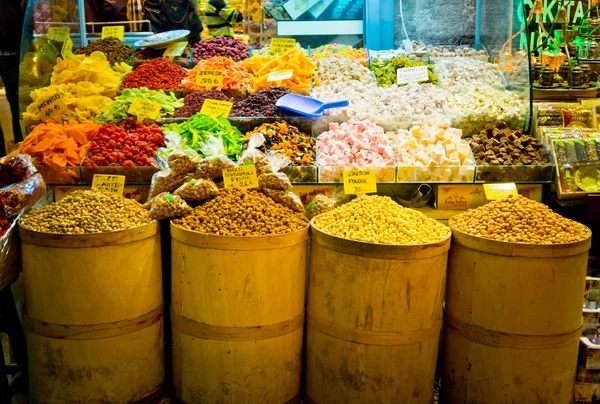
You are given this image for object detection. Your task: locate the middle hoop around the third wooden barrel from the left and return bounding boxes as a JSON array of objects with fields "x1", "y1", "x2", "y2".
[{"x1": 306, "y1": 308, "x2": 442, "y2": 346}]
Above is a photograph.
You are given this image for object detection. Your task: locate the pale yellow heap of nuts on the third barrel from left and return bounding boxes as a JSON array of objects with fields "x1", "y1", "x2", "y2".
[{"x1": 314, "y1": 195, "x2": 450, "y2": 245}]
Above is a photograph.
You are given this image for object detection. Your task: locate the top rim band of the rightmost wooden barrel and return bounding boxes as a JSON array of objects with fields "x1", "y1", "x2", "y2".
[{"x1": 448, "y1": 218, "x2": 592, "y2": 258}]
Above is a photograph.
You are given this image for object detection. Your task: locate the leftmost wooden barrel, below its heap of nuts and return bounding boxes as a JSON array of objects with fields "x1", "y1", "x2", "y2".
[{"x1": 20, "y1": 222, "x2": 164, "y2": 404}]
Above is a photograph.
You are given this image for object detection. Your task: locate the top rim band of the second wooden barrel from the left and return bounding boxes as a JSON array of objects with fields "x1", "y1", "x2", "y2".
[{"x1": 171, "y1": 221, "x2": 308, "y2": 251}]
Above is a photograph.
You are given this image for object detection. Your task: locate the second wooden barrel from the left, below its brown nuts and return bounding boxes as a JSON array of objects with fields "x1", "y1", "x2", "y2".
[{"x1": 171, "y1": 223, "x2": 308, "y2": 404}]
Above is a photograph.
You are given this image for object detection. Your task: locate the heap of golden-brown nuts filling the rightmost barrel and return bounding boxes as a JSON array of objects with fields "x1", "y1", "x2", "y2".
[{"x1": 449, "y1": 196, "x2": 591, "y2": 244}]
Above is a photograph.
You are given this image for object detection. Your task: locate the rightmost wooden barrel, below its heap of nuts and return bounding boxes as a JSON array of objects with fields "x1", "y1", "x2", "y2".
[{"x1": 442, "y1": 226, "x2": 590, "y2": 404}]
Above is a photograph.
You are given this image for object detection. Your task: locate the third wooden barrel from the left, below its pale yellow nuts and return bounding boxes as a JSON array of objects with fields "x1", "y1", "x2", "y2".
[{"x1": 305, "y1": 224, "x2": 450, "y2": 404}]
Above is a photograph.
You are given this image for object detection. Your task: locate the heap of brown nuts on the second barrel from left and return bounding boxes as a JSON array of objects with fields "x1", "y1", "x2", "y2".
[{"x1": 173, "y1": 188, "x2": 308, "y2": 236}]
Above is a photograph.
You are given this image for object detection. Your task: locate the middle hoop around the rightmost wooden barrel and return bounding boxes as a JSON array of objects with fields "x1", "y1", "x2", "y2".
[{"x1": 444, "y1": 310, "x2": 583, "y2": 350}]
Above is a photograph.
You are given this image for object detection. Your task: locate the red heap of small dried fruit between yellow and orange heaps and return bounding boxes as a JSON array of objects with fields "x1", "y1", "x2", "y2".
[{"x1": 121, "y1": 57, "x2": 186, "y2": 91}]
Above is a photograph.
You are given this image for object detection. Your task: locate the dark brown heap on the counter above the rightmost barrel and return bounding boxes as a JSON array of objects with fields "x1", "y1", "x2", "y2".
[{"x1": 470, "y1": 122, "x2": 550, "y2": 165}]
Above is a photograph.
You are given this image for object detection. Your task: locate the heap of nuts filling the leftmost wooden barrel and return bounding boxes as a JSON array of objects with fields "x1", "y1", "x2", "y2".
[{"x1": 21, "y1": 190, "x2": 152, "y2": 234}]
